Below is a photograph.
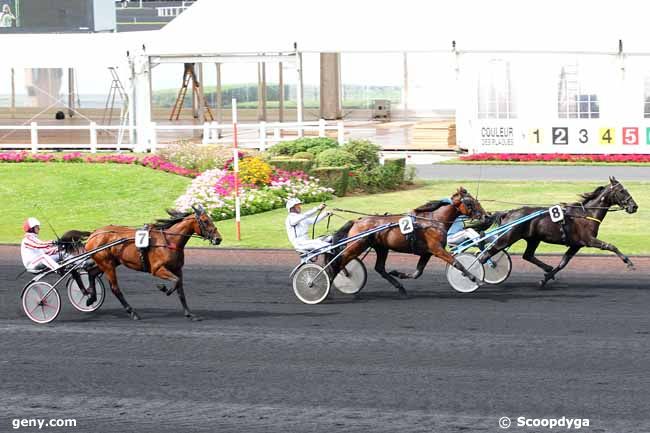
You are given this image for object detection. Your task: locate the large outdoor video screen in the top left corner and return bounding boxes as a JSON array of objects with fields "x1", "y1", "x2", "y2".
[{"x1": 0, "y1": 0, "x2": 116, "y2": 33}]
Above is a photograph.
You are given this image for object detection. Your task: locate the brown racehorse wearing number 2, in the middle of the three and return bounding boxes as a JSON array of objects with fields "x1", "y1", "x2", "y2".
[{"x1": 330, "y1": 187, "x2": 486, "y2": 297}]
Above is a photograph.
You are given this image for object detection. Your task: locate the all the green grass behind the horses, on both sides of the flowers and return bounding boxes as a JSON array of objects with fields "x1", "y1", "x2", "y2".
[{"x1": 0, "y1": 163, "x2": 650, "y2": 254}]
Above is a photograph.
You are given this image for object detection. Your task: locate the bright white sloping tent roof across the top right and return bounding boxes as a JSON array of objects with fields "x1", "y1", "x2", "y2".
[{"x1": 148, "y1": 0, "x2": 650, "y2": 54}]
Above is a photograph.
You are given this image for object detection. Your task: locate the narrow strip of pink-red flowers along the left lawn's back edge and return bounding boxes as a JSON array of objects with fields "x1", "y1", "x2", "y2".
[{"x1": 0, "y1": 151, "x2": 198, "y2": 177}]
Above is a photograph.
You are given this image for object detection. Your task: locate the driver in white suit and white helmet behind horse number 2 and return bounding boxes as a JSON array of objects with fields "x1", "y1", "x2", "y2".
[{"x1": 284, "y1": 198, "x2": 331, "y2": 251}]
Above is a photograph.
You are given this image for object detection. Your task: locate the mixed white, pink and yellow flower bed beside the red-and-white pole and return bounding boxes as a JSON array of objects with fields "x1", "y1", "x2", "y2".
[{"x1": 176, "y1": 158, "x2": 333, "y2": 221}]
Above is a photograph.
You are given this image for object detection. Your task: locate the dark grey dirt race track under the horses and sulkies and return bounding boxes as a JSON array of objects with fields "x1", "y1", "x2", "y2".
[{"x1": 0, "y1": 247, "x2": 650, "y2": 433}]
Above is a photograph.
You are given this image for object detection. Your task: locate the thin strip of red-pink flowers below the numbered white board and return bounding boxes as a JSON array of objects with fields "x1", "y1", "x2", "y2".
[{"x1": 460, "y1": 153, "x2": 650, "y2": 164}]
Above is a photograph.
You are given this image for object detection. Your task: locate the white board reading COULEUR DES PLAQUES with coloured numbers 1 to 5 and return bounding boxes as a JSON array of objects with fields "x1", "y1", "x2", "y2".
[{"x1": 470, "y1": 119, "x2": 650, "y2": 154}]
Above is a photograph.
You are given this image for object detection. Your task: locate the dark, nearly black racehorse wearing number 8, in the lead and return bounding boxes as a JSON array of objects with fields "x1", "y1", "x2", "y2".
[{"x1": 481, "y1": 177, "x2": 639, "y2": 287}]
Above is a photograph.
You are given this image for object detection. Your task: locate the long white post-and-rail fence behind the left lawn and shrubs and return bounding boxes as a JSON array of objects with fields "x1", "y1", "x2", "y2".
[{"x1": 0, "y1": 119, "x2": 345, "y2": 153}]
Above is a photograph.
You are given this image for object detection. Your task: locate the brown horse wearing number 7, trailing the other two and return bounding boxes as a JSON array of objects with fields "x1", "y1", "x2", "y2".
[{"x1": 79, "y1": 207, "x2": 222, "y2": 320}]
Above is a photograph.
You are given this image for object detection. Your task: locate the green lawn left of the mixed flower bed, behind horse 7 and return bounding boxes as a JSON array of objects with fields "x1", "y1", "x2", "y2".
[{"x1": 0, "y1": 163, "x2": 191, "y2": 242}]
